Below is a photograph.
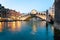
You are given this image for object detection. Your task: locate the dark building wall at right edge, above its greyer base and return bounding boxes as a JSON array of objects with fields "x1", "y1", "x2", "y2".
[{"x1": 55, "y1": 0, "x2": 60, "y2": 23}]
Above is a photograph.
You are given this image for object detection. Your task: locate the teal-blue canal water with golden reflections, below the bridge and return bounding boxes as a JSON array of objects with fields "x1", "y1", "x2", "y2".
[{"x1": 0, "y1": 21, "x2": 54, "y2": 40}]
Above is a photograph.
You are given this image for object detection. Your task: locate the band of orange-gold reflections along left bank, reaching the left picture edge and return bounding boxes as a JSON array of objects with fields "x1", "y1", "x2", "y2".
[{"x1": 0, "y1": 21, "x2": 21, "y2": 32}]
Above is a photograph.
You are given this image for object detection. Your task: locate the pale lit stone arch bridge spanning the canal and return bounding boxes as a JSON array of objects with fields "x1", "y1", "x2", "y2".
[{"x1": 20, "y1": 14, "x2": 46, "y2": 20}]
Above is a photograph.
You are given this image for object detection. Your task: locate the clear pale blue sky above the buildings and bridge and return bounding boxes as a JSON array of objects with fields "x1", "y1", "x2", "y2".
[{"x1": 0, "y1": 0, "x2": 54, "y2": 13}]
